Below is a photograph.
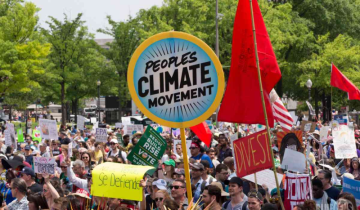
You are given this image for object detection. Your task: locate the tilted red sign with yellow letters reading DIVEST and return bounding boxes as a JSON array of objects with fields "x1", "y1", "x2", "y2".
[{"x1": 234, "y1": 131, "x2": 272, "y2": 177}]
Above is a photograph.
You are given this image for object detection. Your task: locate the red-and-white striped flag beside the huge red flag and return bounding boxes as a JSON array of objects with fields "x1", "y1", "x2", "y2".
[{"x1": 270, "y1": 89, "x2": 294, "y2": 131}]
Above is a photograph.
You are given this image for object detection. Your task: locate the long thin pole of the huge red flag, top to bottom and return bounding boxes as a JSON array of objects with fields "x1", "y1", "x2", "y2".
[{"x1": 249, "y1": 0, "x2": 285, "y2": 210}]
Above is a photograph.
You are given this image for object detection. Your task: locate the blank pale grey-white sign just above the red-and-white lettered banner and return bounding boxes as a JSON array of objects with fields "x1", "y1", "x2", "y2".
[{"x1": 281, "y1": 148, "x2": 306, "y2": 173}]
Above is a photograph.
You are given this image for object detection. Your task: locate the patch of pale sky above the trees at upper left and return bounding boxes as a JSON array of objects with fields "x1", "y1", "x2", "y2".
[{"x1": 27, "y1": 0, "x2": 163, "y2": 39}]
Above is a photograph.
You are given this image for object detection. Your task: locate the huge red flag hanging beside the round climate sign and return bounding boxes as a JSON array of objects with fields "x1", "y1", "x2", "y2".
[{"x1": 218, "y1": 0, "x2": 281, "y2": 127}]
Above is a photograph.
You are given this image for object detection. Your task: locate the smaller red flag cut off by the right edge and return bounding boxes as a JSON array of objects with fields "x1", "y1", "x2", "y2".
[{"x1": 330, "y1": 64, "x2": 360, "y2": 100}]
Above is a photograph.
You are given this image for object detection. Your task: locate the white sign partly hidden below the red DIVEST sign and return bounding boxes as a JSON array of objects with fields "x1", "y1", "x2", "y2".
[{"x1": 242, "y1": 169, "x2": 283, "y2": 192}]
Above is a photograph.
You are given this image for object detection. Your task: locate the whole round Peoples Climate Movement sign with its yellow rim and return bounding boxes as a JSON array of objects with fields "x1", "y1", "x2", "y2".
[{"x1": 127, "y1": 31, "x2": 224, "y2": 128}]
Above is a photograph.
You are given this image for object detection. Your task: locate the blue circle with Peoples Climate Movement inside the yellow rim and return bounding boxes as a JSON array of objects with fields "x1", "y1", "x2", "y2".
[{"x1": 133, "y1": 38, "x2": 218, "y2": 122}]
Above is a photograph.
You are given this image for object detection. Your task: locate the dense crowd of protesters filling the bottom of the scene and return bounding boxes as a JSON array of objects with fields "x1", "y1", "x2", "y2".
[{"x1": 0, "y1": 120, "x2": 360, "y2": 210}]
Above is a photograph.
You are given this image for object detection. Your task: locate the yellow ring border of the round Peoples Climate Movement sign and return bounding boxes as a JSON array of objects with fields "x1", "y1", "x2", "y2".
[{"x1": 127, "y1": 31, "x2": 225, "y2": 128}]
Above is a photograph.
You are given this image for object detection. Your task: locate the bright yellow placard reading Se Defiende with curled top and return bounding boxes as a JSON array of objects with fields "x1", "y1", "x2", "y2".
[{"x1": 91, "y1": 162, "x2": 154, "y2": 201}]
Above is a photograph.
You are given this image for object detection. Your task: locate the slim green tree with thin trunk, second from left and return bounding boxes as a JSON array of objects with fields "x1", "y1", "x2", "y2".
[{"x1": 41, "y1": 13, "x2": 90, "y2": 125}]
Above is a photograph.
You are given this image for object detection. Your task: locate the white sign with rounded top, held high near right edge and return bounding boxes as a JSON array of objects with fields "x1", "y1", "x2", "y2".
[{"x1": 332, "y1": 125, "x2": 357, "y2": 159}]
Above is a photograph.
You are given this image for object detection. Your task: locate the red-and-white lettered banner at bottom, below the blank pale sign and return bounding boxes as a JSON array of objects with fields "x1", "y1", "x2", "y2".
[{"x1": 284, "y1": 173, "x2": 313, "y2": 209}]
